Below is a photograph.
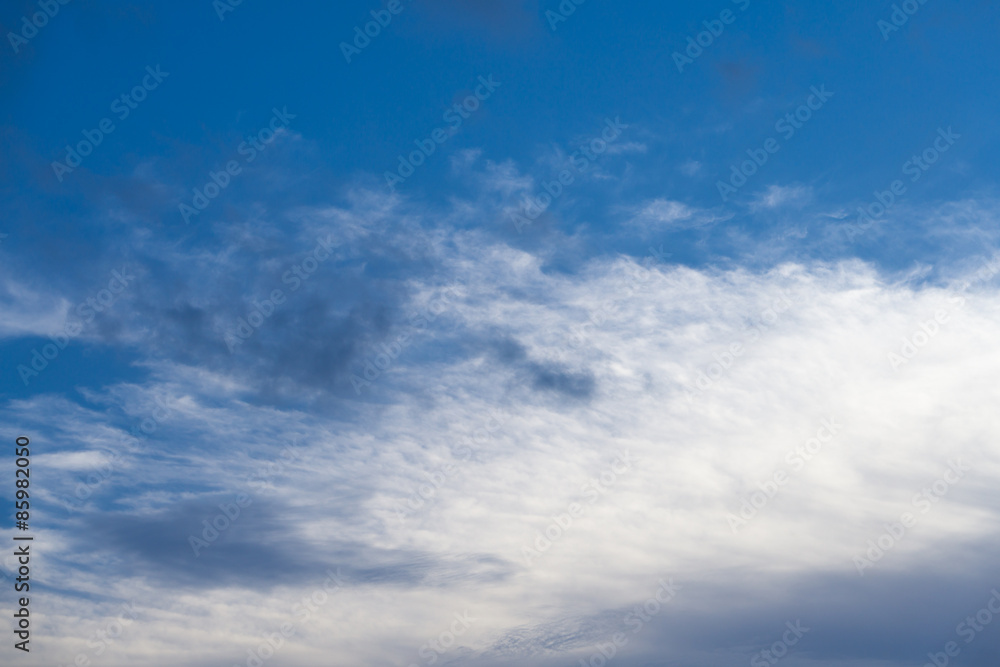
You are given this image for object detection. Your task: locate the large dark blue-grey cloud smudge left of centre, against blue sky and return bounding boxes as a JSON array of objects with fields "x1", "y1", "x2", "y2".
[{"x1": 104, "y1": 213, "x2": 436, "y2": 405}]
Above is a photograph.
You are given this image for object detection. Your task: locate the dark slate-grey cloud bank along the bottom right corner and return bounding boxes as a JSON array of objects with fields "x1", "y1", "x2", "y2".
[{"x1": 456, "y1": 560, "x2": 1000, "y2": 667}]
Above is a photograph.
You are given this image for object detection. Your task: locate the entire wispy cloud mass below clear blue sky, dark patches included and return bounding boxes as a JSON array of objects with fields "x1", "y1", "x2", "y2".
[{"x1": 2, "y1": 137, "x2": 1000, "y2": 667}]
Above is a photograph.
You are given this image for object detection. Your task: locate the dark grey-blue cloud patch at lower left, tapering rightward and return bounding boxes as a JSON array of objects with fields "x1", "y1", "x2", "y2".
[{"x1": 77, "y1": 494, "x2": 513, "y2": 589}]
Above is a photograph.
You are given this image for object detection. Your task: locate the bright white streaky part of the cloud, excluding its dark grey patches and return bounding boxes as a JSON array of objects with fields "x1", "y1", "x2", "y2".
[{"x1": 18, "y1": 234, "x2": 1000, "y2": 666}]
